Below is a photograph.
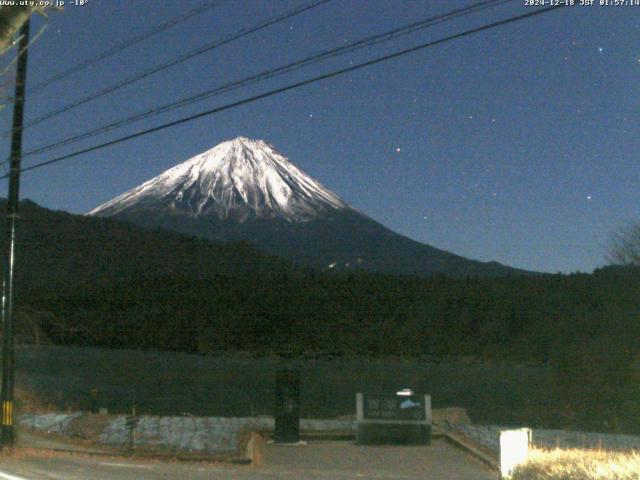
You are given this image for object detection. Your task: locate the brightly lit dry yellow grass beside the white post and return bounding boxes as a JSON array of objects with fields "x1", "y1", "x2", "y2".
[{"x1": 512, "y1": 449, "x2": 640, "y2": 480}]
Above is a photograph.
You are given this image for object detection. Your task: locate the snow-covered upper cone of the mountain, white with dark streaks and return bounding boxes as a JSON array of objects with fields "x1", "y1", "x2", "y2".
[{"x1": 89, "y1": 137, "x2": 350, "y2": 222}]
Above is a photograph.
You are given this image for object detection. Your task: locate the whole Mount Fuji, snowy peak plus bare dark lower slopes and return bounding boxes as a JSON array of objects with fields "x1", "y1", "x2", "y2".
[{"x1": 87, "y1": 137, "x2": 527, "y2": 276}]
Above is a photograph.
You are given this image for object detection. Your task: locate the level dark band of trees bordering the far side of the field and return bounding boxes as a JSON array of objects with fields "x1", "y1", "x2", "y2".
[{"x1": 20, "y1": 267, "x2": 640, "y2": 362}]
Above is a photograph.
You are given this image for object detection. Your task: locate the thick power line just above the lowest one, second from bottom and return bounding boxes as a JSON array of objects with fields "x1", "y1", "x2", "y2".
[{"x1": 24, "y1": 0, "x2": 513, "y2": 156}]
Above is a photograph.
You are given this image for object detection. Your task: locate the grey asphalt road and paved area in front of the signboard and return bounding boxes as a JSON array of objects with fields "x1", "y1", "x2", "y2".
[{"x1": 0, "y1": 440, "x2": 496, "y2": 480}]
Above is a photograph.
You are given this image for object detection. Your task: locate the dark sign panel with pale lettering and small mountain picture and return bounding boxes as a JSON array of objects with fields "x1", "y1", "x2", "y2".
[{"x1": 362, "y1": 394, "x2": 426, "y2": 421}]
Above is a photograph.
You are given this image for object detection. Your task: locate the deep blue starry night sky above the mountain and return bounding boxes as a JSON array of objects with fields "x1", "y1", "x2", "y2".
[{"x1": 0, "y1": 0, "x2": 640, "y2": 272}]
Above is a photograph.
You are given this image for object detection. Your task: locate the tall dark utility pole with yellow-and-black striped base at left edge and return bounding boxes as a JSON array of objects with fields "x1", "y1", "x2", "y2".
[{"x1": 0, "y1": 20, "x2": 30, "y2": 447}]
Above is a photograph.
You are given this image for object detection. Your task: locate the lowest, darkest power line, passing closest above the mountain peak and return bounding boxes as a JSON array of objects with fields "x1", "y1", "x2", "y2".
[{"x1": 5, "y1": 5, "x2": 564, "y2": 179}]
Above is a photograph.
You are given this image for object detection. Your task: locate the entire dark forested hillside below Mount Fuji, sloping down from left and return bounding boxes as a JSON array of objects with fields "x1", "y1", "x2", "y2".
[{"x1": 5, "y1": 199, "x2": 640, "y2": 430}]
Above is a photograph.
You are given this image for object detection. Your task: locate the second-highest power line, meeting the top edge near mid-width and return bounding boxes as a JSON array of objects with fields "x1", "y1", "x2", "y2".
[{"x1": 0, "y1": 0, "x2": 331, "y2": 138}]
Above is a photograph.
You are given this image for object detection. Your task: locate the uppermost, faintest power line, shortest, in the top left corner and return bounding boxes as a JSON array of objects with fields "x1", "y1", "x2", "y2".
[{"x1": 29, "y1": 0, "x2": 229, "y2": 94}]
